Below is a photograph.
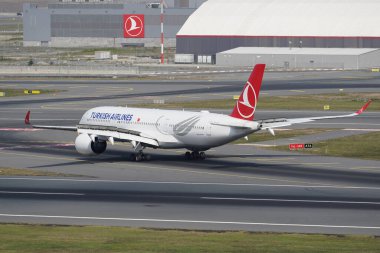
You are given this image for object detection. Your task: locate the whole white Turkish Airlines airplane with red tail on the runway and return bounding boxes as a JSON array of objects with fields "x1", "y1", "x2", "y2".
[{"x1": 25, "y1": 64, "x2": 371, "y2": 161}]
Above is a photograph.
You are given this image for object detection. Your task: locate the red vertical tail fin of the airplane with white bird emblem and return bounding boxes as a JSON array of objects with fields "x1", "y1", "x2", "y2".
[{"x1": 230, "y1": 64, "x2": 265, "y2": 120}]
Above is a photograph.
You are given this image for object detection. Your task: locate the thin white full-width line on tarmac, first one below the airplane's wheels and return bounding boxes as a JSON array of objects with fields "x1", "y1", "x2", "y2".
[{"x1": 0, "y1": 177, "x2": 380, "y2": 190}]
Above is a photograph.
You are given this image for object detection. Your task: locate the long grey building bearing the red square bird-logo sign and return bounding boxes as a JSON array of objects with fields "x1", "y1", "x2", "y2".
[{"x1": 23, "y1": 0, "x2": 205, "y2": 47}]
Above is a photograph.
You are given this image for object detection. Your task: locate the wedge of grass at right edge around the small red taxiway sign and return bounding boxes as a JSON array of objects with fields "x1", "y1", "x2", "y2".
[{"x1": 271, "y1": 132, "x2": 380, "y2": 160}]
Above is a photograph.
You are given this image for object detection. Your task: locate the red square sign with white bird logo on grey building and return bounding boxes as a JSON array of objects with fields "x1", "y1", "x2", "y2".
[{"x1": 124, "y1": 14, "x2": 145, "y2": 38}]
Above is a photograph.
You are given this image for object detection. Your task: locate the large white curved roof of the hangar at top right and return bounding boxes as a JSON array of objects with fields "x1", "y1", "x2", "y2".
[{"x1": 177, "y1": 0, "x2": 380, "y2": 37}]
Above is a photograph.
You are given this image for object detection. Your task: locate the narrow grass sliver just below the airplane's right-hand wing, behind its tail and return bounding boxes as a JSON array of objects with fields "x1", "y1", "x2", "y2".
[{"x1": 234, "y1": 128, "x2": 338, "y2": 144}]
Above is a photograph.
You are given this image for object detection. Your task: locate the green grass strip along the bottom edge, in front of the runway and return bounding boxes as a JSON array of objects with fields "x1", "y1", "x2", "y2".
[{"x1": 0, "y1": 224, "x2": 380, "y2": 253}]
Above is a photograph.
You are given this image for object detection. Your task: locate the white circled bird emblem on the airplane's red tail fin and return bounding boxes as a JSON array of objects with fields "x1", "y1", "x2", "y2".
[{"x1": 236, "y1": 82, "x2": 257, "y2": 119}]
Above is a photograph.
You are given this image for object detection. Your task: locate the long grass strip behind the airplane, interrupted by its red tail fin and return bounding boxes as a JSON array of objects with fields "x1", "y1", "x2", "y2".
[{"x1": 133, "y1": 93, "x2": 380, "y2": 111}]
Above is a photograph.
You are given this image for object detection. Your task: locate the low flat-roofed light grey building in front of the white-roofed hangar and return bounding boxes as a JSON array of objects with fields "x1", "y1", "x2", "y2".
[{"x1": 216, "y1": 47, "x2": 380, "y2": 70}]
